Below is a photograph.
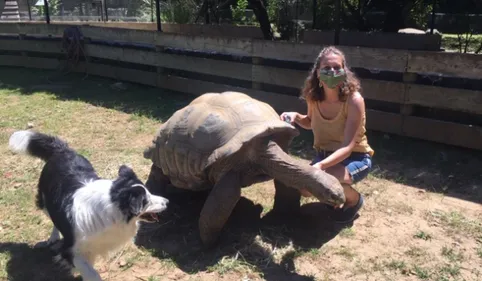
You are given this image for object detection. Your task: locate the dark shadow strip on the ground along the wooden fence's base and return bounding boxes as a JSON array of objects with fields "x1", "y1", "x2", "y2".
[{"x1": 0, "y1": 67, "x2": 482, "y2": 203}]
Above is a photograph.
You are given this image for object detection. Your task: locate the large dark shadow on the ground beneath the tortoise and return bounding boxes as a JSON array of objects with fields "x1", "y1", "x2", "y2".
[{"x1": 136, "y1": 190, "x2": 351, "y2": 281}]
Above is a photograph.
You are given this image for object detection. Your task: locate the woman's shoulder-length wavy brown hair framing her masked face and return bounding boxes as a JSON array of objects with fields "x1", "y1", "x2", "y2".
[{"x1": 301, "y1": 46, "x2": 361, "y2": 102}]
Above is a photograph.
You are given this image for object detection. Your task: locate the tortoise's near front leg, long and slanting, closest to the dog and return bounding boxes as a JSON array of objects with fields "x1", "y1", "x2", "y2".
[{"x1": 199, "y1": 171, "x2": 241, "y2": 248}]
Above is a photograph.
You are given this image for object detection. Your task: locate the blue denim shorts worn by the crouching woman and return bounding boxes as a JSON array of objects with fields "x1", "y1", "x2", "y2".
[{"x1": 311, "y1": 151, "x2": 372, "y2": 184}]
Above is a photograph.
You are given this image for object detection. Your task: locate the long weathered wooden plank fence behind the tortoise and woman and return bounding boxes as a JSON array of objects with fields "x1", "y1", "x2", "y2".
[{"x1": 0, "y1": 23, "x2": 482, "y2": 150}]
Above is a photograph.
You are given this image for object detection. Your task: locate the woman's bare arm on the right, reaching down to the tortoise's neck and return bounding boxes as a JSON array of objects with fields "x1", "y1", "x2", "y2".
[{"x1": 318, "y1": 93, "x2": 365, "y2": 170}]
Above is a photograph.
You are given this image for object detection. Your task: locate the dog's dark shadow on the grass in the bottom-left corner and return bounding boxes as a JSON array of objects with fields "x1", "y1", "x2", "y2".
[{"x1": 0, "y1": 243, "x2": 82, "y2": 281}]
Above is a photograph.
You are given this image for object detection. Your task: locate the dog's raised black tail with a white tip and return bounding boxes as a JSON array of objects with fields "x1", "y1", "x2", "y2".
[{"x1": 8, "y1": 130, "x2": 70, "y2": 161}]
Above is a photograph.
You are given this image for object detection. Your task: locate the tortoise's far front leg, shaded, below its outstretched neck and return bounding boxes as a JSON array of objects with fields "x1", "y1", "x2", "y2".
[{"x1": 272, "y1": 179, "x2": 301, "y2": 214}]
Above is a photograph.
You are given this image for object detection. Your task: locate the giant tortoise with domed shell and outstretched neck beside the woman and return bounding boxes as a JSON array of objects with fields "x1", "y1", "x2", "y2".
[{"x1": 144, "y1": 91, "x2": 345, "y2": 247}]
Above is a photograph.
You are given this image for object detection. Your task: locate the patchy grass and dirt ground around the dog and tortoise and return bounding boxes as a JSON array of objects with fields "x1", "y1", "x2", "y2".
[{"x1": 0, "y1": 68, "x2": 482, "y2": 281}]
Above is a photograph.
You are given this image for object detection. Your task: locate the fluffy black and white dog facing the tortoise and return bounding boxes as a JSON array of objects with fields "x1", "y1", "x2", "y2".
[{"x1": 9, "y1": 130, "x2": 168, "y2": 281}]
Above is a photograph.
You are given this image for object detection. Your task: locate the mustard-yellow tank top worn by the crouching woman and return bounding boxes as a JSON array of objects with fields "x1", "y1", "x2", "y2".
[{"x1": 311, "y1": 98, "x2": 375, "y2": 156}]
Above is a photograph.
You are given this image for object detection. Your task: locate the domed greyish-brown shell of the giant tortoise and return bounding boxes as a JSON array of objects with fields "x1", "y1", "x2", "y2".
[{"x1": 144, "y1": 91, "x2": 299, "y2": 189}]
